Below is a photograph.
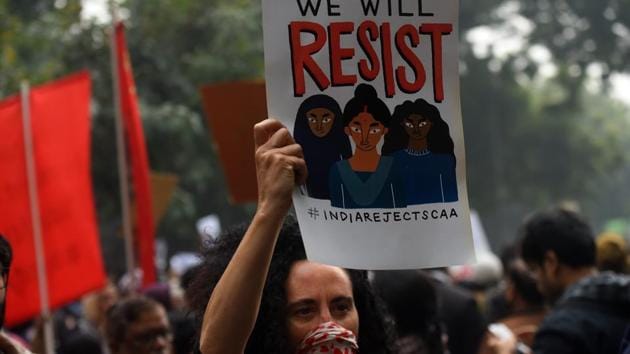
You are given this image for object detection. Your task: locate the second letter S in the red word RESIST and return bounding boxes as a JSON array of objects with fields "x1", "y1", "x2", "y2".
[{"x1": 396, "y1": 25, "x2": 427, "y2": 93}]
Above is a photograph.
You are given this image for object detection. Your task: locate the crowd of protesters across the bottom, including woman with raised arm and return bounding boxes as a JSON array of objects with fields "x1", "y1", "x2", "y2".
[{"x1": 0, "y1": 119, "x2": 630, "y2": 354}]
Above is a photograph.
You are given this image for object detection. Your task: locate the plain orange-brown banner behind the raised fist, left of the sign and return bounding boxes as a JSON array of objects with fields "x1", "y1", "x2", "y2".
[{"x1": 201, "y1": 81, "x2": 267, "y2": 203}]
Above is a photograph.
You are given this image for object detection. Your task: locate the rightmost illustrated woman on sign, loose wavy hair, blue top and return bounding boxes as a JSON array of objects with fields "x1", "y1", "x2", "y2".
[{"x1": 383, "y1": 99, "x2": 458, "y2": 205}]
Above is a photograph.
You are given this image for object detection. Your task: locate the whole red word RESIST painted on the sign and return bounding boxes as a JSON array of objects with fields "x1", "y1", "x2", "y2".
[{"x1": 289, "y1": 20, "x2": 453, "y2": 102}]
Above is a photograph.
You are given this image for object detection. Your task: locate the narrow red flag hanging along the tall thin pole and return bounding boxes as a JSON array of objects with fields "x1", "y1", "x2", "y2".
[{"x1": 116, "y1": 23, "x2": 156, "y2": 285}]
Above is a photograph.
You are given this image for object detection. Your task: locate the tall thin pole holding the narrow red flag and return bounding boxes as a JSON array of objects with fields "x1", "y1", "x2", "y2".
[{"x1": 109, "y1": 1, "x2": 138, "y2": 292}]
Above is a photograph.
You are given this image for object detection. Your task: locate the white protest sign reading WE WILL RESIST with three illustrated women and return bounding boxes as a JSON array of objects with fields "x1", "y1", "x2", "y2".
[{"x1": 263, "y1": 0, "x2": 475, "y2": 269}]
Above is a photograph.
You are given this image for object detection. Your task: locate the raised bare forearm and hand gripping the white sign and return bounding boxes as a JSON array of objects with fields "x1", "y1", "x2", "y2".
[{"x1": 200, "y1": 119, "x2": 306, "y2": 354}]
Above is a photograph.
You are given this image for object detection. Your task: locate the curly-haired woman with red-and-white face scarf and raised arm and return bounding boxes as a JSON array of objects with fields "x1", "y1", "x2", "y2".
[{"x1": 191, "y1": 119, "x2": 390, "y2": 354}]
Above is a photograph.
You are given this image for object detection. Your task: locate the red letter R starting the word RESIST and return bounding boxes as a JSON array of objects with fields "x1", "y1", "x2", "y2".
[{"x1": 289, "y1": 21, "x2": 330, "y2": 97}]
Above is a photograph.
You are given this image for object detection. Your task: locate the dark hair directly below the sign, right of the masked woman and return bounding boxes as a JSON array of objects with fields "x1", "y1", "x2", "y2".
[{"x1": 373, "y1": 270, "x2": 444, "y2": 354}]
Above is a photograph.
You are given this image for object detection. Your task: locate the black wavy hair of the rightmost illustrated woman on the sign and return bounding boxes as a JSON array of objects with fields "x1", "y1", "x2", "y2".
[{"x1": 383, "y1": 98, "x2": 454, "y2": 155}]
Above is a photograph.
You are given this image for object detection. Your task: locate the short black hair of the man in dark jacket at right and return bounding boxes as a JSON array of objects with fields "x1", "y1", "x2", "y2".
[{"x1": 519, "y1": 208, "x2": 595, "y2": 268}]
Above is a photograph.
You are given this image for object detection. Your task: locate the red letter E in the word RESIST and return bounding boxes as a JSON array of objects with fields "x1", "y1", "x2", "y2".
[{"x1": 328, "y1": 22, "x2": 357, "y2": 86}]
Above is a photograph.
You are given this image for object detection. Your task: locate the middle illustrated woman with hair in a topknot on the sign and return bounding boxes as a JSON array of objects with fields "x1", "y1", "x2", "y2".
[{"x1": 329, "y1": 84, "x2": 406, "y2": 209}]
